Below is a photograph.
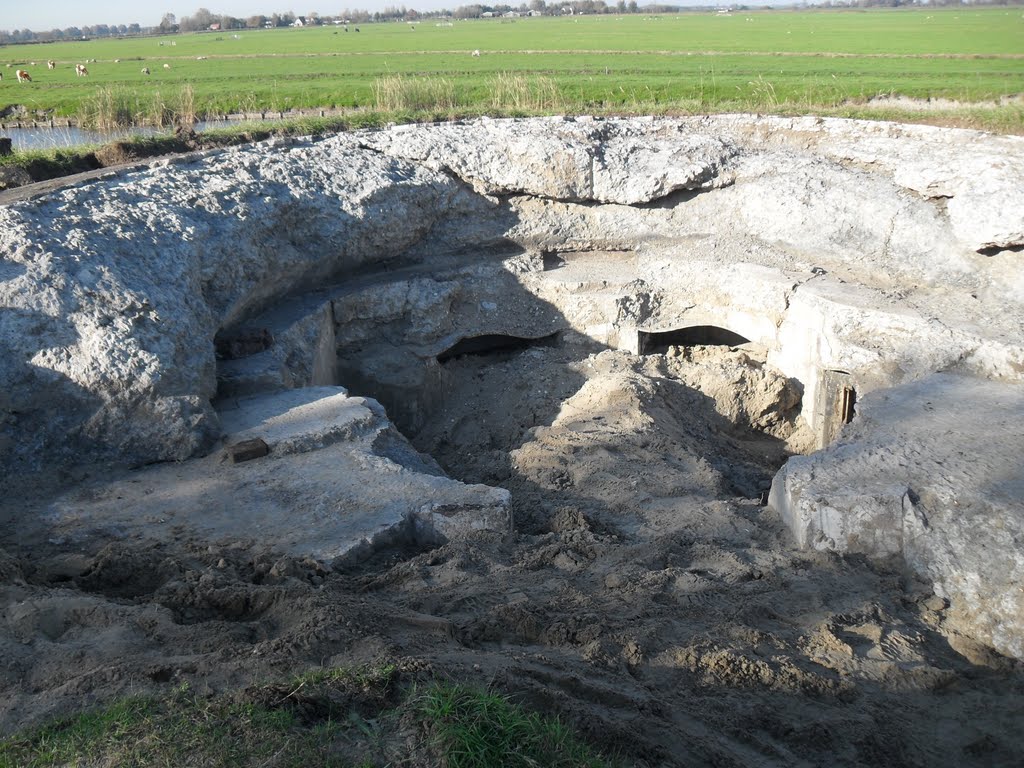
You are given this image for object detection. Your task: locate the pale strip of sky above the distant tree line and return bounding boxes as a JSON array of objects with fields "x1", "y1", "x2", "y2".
[{"x1": 0, "y1": 0, "x2": 452, "y2": 32}]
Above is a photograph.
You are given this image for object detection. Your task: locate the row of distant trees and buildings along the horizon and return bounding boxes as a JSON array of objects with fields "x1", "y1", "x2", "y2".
[{"x1": 0, "y1": 0, "x2": 1024, "y2": 45}]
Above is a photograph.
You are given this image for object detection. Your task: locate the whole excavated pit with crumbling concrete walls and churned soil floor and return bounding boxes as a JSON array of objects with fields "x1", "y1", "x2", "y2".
[{"x1": 0, "y1": 116, "x2": 1024, "y2": 767}]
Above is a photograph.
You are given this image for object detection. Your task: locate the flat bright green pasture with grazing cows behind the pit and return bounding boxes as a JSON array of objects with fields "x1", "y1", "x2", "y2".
[{"x1": 0, "y1": 7, "x2": 1024, "y2": 128}]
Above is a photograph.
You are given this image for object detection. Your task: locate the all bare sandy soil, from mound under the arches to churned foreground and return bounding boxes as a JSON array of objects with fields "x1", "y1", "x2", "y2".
[{"x1": 0, "y1": 343, "x2": 1024, "y2": 766}]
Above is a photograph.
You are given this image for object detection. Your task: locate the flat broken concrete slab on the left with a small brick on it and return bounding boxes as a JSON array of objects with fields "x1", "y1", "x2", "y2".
[{"x1": 42, "y1": 388, "x2": 511, "y2": 565}]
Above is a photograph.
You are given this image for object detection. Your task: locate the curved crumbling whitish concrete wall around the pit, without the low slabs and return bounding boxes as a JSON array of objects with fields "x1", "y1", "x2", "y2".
[{"x1": 0, "y1": 117, "x2": 1024, "y2": 479}]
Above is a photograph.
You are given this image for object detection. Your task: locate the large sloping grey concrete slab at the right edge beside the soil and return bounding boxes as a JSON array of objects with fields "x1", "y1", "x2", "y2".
[{"x1": 769, "y1": 374, "x2": 1024, "y2": 658}]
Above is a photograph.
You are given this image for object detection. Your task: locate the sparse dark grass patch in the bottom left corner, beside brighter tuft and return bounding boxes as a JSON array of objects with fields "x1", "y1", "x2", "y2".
[{"x1": 0, "y1": 667, "x2": 396, "y2": 768}]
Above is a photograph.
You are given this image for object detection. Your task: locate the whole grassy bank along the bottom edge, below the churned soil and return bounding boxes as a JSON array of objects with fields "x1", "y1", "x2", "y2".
[{"x1": 0, "y1": 667, "x2": 610, "y2": 768}]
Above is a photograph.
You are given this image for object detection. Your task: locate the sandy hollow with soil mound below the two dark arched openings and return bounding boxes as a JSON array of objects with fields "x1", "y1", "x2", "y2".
[{"x1": 331, "y1": 327, "x2": 809, "y2": 507}]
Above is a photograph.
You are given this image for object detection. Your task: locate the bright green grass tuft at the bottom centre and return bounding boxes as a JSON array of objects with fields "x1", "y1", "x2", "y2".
[{"x1": 418, "y1": 683, "x2": 607, "y2": 768}]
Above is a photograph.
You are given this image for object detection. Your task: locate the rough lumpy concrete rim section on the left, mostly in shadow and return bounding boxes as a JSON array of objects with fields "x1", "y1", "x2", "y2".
[{"x1": 0, "y1": 136, "x2": 455, "y2": 470}]
